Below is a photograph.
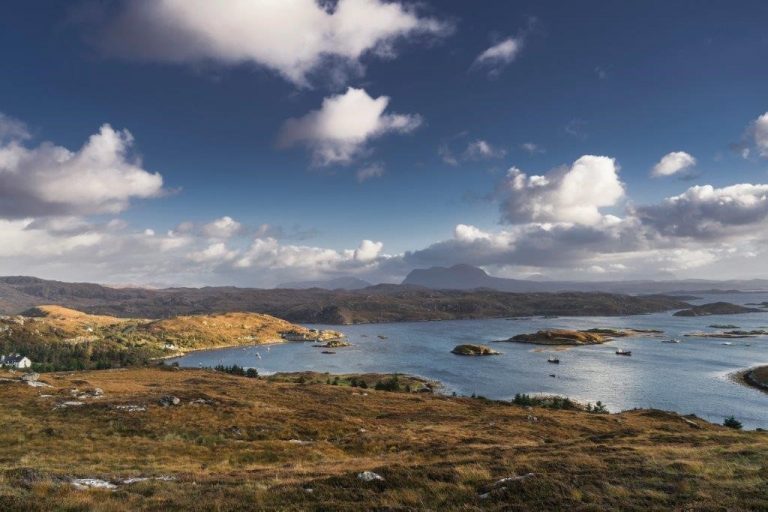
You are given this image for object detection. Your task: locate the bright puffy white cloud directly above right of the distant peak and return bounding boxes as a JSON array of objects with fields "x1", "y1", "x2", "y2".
[{"x1": 500, "y1": 155, "x2": 624, "y2": 225}]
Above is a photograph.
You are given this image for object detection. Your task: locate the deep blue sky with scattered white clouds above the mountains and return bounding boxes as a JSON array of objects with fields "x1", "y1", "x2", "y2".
[{"x1": 0, "y1": 0, "x2": 768, "y2": 287}]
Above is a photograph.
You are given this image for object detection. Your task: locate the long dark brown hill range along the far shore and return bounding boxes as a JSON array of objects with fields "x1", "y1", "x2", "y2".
[{"x1": 0, "y1": 278, "x2": 690, "y2": 325}]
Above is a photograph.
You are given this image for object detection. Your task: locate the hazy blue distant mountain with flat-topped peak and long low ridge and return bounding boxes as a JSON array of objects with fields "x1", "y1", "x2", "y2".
[{"x1": 403, "y1": 264, "x2": 768, "y2": 294}]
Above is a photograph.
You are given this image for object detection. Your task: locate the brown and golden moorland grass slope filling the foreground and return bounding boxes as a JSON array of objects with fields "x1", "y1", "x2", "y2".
[{"x1": 0, "y1": 369, "x2": 768, "y2": 511}]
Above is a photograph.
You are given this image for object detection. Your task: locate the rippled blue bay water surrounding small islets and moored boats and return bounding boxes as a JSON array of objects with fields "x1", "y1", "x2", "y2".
[{"x1": 171, "y1": 293, "x2": 768, "y2": 428}]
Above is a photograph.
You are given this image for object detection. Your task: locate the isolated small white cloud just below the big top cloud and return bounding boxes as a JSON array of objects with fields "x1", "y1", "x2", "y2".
[{"x1": 280, "y1": 87, "x2": 421, "y2": 165}]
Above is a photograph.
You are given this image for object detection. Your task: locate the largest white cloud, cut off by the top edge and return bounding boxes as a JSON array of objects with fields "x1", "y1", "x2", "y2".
[{"x1": 96, "y1": 0, "x2": 450, "y2": 85}]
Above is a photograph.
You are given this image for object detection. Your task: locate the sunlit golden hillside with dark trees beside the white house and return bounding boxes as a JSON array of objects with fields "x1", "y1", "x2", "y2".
[{"x1": 0, "y1": 306, "x2": 340, "y2": 371}]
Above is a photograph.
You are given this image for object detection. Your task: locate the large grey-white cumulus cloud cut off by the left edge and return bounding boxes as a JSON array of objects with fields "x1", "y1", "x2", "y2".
[{"x1": 0, "y1": 124, "x2": 163, "y2": 218}]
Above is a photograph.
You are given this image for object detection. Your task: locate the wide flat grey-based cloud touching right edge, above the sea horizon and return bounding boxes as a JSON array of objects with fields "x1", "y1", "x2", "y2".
[{"x1": 635, "y1": 183, "x2": 768, "y2": 239}]
